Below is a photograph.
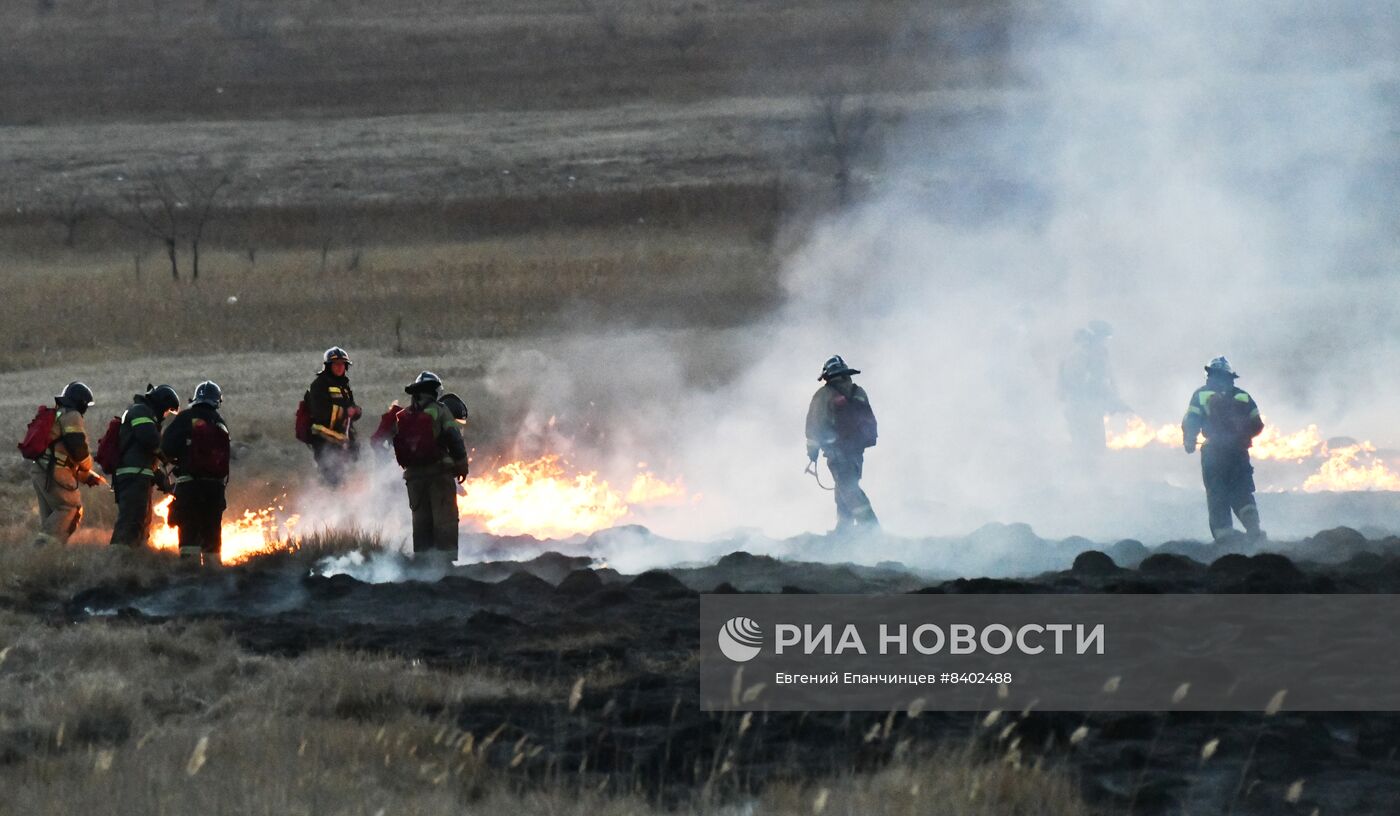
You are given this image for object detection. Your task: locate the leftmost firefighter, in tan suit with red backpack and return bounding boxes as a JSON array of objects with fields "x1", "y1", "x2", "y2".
[{"x1": 29, "y1": 382, "x2": 102, "y2": 544}]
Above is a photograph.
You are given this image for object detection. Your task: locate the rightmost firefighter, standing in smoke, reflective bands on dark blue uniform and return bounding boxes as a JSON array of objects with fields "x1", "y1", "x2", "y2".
[{"x1": 1182, "y1": 357, "x2": 1266, "y2": 540}]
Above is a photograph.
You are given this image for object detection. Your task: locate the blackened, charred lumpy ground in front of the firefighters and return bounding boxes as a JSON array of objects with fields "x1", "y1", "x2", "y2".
[{"x1": 50, "y1": 525, "x2": 1400, "y2": 813}]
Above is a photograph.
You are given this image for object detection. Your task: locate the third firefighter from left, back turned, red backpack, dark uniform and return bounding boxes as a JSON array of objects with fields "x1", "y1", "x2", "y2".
[{"x1": 161, "y1": 379, "x2": 230, "y2": 568}]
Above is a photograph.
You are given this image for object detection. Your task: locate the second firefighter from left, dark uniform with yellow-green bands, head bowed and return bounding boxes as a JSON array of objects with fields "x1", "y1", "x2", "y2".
[{"x1": 112, "y1": 385, "x2": 179, "y2": 547}]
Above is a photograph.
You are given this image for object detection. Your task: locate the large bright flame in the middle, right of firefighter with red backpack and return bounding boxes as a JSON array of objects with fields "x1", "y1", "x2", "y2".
[{"x1": 456, "y1": 455, "x2": 686, "y2": 539}]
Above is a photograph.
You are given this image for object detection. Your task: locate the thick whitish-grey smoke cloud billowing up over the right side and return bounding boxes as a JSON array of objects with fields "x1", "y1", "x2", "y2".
[{"x1": 512, "y1": 0, "x2": 1400, "y2": 548}]
